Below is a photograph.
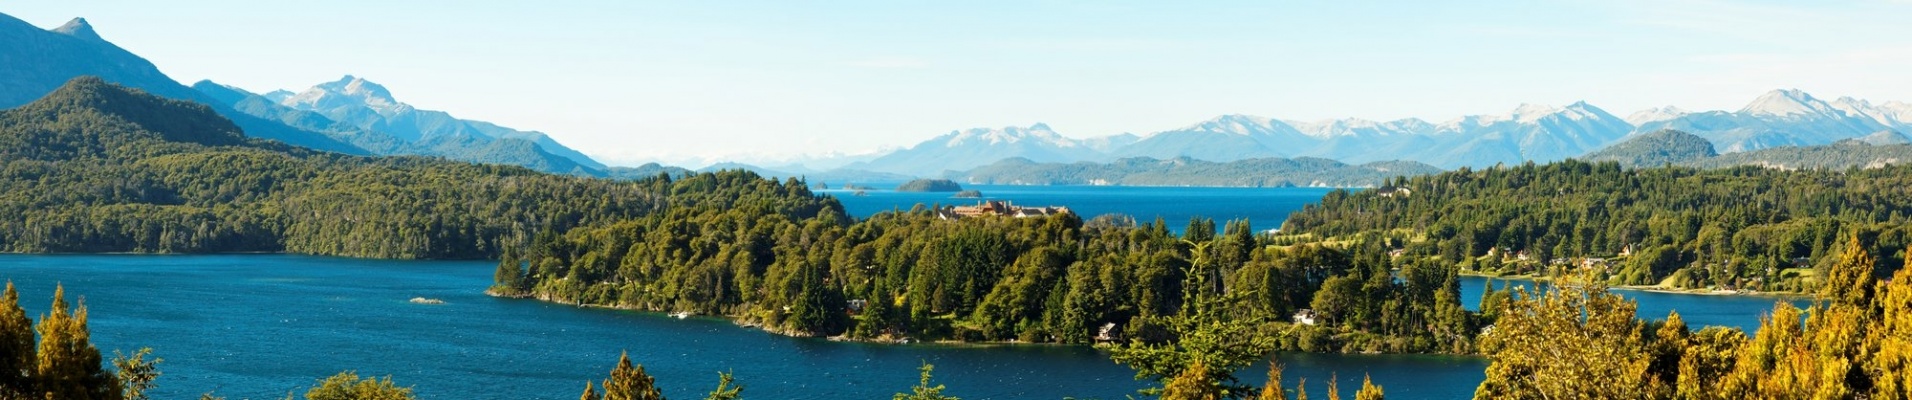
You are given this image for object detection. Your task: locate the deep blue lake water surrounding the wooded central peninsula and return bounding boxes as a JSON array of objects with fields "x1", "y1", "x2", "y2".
[{"x1": 0, "y1": 186, "x2": 1804, "y2": 400}]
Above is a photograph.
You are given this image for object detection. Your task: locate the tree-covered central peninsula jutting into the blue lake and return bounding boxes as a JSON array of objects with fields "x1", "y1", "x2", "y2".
[{"x1": 493, "y1": 193, "x2": 1484, "y2": 352}]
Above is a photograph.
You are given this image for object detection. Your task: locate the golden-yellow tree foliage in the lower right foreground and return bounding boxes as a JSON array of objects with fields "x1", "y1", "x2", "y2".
[{"x1": 1476, "y1": 239, "x2": 1912, "y2": 400}]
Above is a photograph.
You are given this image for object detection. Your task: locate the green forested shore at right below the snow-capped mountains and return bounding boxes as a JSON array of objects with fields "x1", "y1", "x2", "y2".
[{"x1": 1283, "y1": 161, "x2": 1912, "y2": 291}]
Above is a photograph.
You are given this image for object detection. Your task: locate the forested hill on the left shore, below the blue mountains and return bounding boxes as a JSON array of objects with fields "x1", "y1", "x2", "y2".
[{"x1": 0, "y1": 77, "x2": 776, "y2": 258}]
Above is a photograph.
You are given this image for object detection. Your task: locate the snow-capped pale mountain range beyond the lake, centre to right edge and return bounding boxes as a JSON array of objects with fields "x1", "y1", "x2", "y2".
[{"x1": 818, "y1": 90, "x2": 1912, "y2": 176}]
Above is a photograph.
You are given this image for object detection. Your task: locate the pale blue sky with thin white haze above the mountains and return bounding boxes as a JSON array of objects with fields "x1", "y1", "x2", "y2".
[{"x1": 0, "y1": 0, "x2": 1912, "y2": 167}]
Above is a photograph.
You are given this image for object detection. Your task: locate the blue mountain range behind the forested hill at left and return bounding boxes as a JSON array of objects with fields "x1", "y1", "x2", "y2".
[{"x1": 0, "y1": 13, "x2": 616, "y2": 176}]
